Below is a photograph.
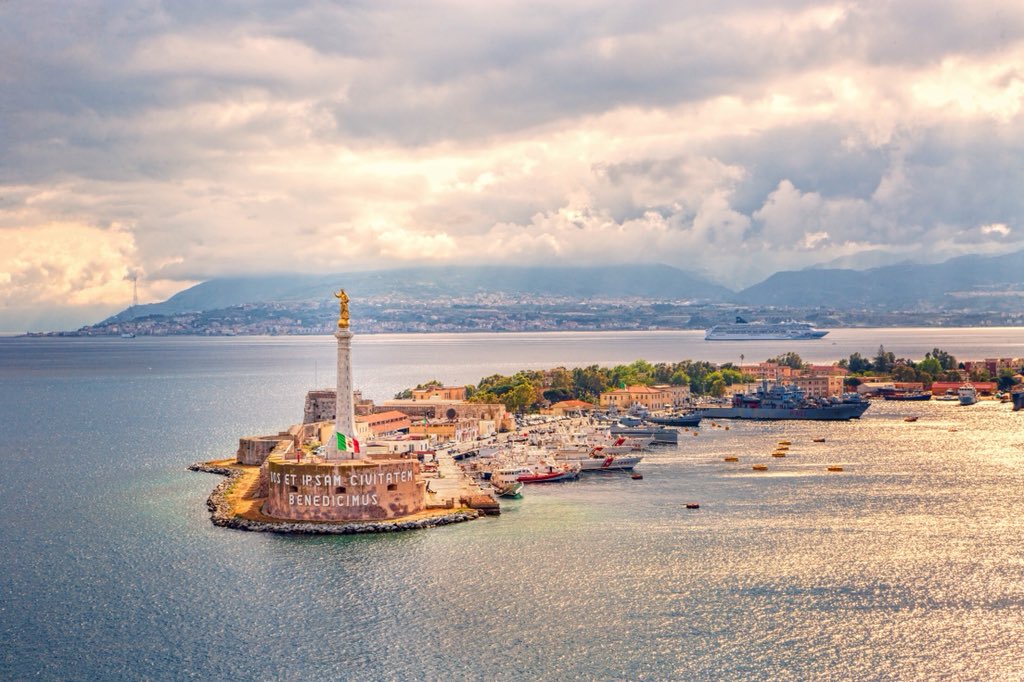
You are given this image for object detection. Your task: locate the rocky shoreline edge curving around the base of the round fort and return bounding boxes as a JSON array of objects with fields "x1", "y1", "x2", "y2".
[{"x1": 188, "y1": 462, "x2": 481, "y2": 536}]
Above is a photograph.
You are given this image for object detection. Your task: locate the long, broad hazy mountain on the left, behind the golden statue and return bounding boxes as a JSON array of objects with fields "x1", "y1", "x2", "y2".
[{"x1": 104, "y1": 265, "x2": 733, "y2": 323}]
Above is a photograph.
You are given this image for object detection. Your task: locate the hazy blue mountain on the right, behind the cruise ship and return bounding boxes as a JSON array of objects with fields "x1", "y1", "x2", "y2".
[{"x1": 734, "y1": 252, "x2": 1024, "y2": 309}]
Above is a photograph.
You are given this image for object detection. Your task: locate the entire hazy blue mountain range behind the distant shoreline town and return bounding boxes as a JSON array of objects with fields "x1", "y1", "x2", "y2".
[{"x1": 108, "y1": 252, "x2": 1024, "y2": 322}]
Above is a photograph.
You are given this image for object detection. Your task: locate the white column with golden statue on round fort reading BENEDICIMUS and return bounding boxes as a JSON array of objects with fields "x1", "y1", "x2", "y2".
[{"x1": 262, "y1": 291, "x2": 426, "y2": 521}]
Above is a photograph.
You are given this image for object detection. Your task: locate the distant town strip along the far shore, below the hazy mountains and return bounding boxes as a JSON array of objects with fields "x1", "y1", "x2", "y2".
[{"x1": 32, "y1": 294, "x2": 1024, "y2": 336}]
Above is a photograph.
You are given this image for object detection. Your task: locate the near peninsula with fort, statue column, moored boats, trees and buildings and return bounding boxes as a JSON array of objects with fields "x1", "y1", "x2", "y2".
[{"x1": 191, "y1": 291, "x2": 1024, "y2": 534}]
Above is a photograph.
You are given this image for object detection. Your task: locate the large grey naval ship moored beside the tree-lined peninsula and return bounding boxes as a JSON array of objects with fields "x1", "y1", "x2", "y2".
[{"x1": 696, "y1": 381, "x2": 869, "y2": 421}]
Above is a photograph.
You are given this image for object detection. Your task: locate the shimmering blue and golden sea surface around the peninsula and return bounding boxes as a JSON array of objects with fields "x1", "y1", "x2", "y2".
[{"x1": 0, "y1": 329, "x2": 1024, "y2": 680}]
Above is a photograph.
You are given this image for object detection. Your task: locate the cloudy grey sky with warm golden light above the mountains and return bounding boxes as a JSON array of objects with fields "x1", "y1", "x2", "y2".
[{"x1": 0, "y1": 0, "x2": 1024, "y2": 331}]
